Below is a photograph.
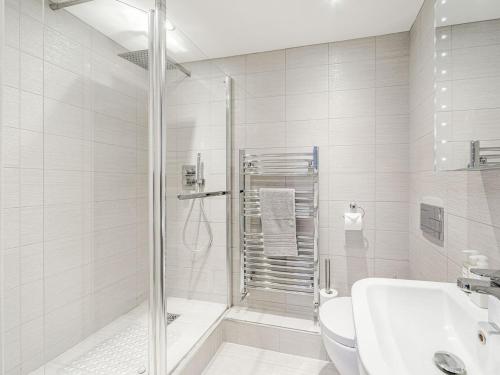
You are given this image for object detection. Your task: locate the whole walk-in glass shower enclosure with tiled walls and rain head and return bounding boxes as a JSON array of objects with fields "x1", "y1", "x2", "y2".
[{"x1": 0, "y1": 0, "x2": 232, "y2": 375}]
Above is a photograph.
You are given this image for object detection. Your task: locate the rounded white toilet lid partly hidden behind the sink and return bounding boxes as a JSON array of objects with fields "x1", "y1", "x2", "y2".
[{"x1": 319, "y1": 297, "x2": 356, "y2": 348}]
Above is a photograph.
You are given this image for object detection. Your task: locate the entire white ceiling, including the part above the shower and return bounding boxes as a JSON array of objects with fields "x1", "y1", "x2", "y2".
[{"x1": 67, "y1": 0, "x2": 430, "y2": 62}]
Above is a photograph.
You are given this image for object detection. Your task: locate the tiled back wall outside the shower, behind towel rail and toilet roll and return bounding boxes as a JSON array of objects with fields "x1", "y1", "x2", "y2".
[{"x1": 210, "y1": 33, "x2": 409, "y2": 316}]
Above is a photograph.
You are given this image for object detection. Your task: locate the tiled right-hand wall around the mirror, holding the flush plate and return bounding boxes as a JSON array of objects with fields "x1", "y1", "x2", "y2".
[{"x1": 410, "y1": 0, "x2": 500, "y2": 282}]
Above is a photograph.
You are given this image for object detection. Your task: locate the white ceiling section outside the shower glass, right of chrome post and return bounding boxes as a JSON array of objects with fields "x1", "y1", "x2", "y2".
[{"x1": 167, "y1": 0, "x2": 423, "y2": 57}]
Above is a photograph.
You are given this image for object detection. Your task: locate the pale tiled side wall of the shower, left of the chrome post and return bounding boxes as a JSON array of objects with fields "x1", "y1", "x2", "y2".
[{"x1": 1, "y1": 0, "x2": 147, "y2": 375}]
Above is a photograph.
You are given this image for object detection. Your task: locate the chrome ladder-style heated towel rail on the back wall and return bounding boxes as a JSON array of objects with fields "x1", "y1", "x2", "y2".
[{"x1": 239, "y1": 147, "x2": 319, "y2": 317}]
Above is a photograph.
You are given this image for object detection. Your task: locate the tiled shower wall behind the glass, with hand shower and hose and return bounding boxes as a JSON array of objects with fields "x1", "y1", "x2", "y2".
[{"x1": 167, "y1": 61, "x2": 227, "y2": 304}]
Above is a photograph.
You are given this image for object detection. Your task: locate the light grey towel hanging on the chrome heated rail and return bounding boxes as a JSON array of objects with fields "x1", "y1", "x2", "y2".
[{"x1": 259, "y1": 188, "x2": 298, "y2": 256}]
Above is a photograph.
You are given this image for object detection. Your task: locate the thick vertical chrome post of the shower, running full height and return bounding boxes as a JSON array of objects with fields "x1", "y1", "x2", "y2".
[{"x1": 148, "y1": 0, "x2": 167, "y2": 375}]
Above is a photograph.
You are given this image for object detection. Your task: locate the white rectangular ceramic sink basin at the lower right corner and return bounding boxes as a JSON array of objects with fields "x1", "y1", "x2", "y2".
[{"x1": 352, "y1": 279, "x2": 500, "y2": 375}]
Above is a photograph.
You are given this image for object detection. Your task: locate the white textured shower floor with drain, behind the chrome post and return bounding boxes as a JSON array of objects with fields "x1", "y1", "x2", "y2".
[{"x1": 30, "y1": 298, "x2": 226, "y2": 375}]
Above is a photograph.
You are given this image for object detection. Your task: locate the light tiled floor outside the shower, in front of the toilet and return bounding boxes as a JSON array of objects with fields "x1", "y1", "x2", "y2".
[{"x1": 203, "y1": 342, "x2": 339, "y2": 375}]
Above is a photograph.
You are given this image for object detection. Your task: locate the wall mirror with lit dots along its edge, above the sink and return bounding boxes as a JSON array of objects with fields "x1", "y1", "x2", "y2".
[{"x1": 434, "y1": 0, "x2": 500, "y2": 171}]
